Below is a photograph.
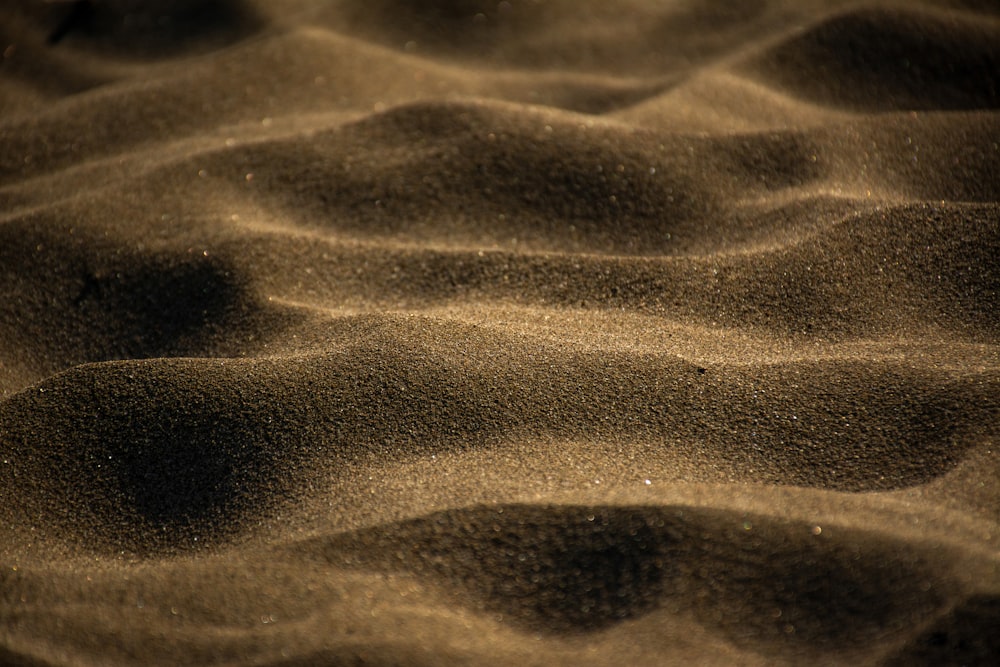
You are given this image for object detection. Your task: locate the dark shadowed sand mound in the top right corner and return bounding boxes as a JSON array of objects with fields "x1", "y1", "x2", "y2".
[{"x1": 745, "y1": 9, "x2": 1000, "y2": 112}]
